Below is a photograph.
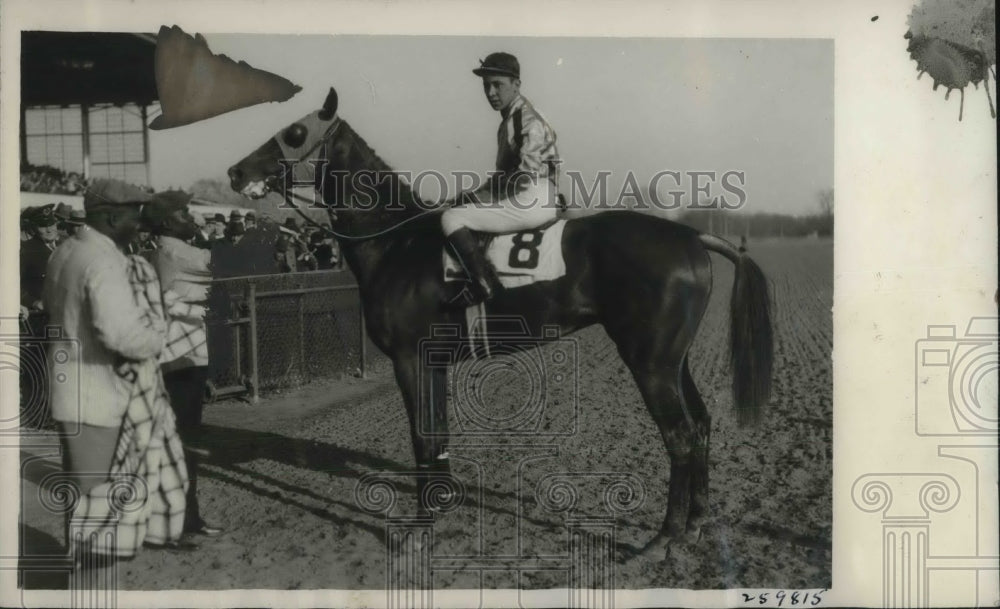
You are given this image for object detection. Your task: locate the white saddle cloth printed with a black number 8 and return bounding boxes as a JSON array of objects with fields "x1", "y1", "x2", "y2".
[{"x1": 442, "y1": 220, "x2": 566, "y2": 288}]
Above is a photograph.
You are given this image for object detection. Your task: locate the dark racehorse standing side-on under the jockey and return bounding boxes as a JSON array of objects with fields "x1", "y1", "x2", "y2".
[{"x1": 229, "y1": 89, "x2": 773, "y2": 551}]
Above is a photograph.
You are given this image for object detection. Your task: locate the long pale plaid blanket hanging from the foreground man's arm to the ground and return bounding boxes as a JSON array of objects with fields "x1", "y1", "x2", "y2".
[{"x1": 69, "y1": 255, "x2": 188, "y2": 557}]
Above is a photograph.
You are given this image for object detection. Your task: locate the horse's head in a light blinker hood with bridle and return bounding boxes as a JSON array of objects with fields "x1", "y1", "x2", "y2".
[{"x1": 228, "y1": 87, "x2": 341, "y2": 199}]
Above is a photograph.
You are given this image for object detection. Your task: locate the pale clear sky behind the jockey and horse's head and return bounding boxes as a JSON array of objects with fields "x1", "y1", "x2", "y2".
[{"x1": 150, "y1": 34, "x2": 834, "y2": 215}]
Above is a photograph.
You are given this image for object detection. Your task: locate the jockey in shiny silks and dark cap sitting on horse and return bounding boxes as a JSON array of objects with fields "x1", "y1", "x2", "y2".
[{"x1": 441, "y1": 53, "x2": 559, "y2": 304}]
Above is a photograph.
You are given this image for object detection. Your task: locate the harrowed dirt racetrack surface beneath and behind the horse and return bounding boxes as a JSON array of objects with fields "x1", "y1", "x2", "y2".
[{"x1": 25, "y1": 241, "x2": 833, "y2": 589}]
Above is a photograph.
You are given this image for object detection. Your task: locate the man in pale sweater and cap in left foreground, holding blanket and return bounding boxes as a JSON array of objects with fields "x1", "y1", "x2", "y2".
[{"x1": 43, "y1": 180, "x2": 171, "y2": 556}]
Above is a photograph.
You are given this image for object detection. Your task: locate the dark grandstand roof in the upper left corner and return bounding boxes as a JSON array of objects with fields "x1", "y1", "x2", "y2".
[{"x1": 21, "y1": 32, "x2": 158, "y2": 106}]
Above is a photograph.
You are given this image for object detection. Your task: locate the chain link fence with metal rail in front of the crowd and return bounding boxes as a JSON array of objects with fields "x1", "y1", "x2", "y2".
[{"x1": 206, "y1": 271, "x2": 388, "y2": 399}]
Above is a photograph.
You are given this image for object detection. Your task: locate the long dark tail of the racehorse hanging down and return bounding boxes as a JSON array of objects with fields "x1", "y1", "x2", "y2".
[{"x1": 699, "y1": 234, "x2": 774, "y2": 427}]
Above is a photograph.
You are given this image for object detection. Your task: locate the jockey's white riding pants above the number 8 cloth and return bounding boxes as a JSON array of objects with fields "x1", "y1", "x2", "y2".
[{"x1": 441, "y1": 180, "x2": 559, "y2": 236}]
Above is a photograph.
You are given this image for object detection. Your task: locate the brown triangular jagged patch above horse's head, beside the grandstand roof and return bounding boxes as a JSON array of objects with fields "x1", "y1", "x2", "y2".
[{"x1": 149, "y1": 25, "x2": 302, "y2": 129}]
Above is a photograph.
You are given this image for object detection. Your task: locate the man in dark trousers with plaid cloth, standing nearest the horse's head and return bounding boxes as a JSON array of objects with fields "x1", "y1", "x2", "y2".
[{"x1": 142, "y1": 190, "x2": 222, "y2": 536}]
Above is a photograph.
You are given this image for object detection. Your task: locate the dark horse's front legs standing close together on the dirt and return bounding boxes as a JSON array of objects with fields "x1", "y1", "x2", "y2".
[{"x1": 394, "y1": 357, "x2": 451, "y2": 515}]
